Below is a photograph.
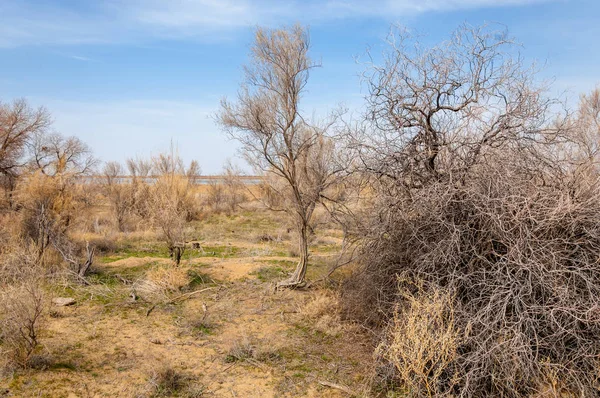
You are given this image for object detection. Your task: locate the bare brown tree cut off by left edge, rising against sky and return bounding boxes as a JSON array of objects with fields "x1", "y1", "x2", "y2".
[{"x1": 0, "y1": 99, "x2": 51, "y2": 205}]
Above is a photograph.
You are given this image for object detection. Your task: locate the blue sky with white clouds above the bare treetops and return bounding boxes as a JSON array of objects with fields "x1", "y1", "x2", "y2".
[{"x1": 0, "y1": 0, "x2": 600, "y2": 174}]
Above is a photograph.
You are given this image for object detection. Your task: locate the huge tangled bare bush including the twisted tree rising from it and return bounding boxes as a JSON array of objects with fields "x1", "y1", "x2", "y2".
[{"x1": 345, "y1": 26, "x2": 600, "y2": 397}]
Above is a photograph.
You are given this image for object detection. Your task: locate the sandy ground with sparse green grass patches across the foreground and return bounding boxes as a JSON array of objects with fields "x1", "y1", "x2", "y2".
[{"x1": 0, "y1": 222, "x2": 372, "y2": 398}]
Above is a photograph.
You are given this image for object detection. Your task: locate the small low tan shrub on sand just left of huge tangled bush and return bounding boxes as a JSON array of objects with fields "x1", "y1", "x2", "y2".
[{"x1": 298, "y1": 292, "x2": 343, "y2": 336}]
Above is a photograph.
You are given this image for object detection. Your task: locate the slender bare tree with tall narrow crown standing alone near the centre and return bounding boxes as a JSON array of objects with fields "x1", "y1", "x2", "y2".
[{"x1": 218, "y1": 26, "x2": 342, "y2": 287}]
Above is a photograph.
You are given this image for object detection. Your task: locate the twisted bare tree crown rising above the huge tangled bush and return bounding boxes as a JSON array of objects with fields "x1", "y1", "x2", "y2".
[{"x1": 359, "y1": 25, "x2": 556, "y2": 188}]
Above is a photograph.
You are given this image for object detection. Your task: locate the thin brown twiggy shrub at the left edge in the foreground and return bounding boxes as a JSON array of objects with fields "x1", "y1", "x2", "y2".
[{"x1": 0, "y1": 281, "x2": 46, "y2": 368}]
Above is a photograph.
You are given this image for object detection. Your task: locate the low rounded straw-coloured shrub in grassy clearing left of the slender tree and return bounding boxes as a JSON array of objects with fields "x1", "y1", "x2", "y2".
[{"x1": 135, "y1": 267, "x2": 190, "y2": 302}]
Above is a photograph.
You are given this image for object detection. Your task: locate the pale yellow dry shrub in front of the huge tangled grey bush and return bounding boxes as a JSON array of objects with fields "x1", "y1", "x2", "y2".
[{"x1": 377, "y1": 291, "x2": 461, "y2": 397}]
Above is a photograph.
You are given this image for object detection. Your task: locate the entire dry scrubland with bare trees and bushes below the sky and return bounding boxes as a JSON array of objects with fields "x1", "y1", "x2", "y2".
[{"x1": 0, "y1": 21, "x2": 600, "y2": 398}]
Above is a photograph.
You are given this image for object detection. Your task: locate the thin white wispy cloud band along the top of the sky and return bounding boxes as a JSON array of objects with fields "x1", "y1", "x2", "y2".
[{"x1": 0, "y1": 0, "x2": 553, "y2": 47}]
